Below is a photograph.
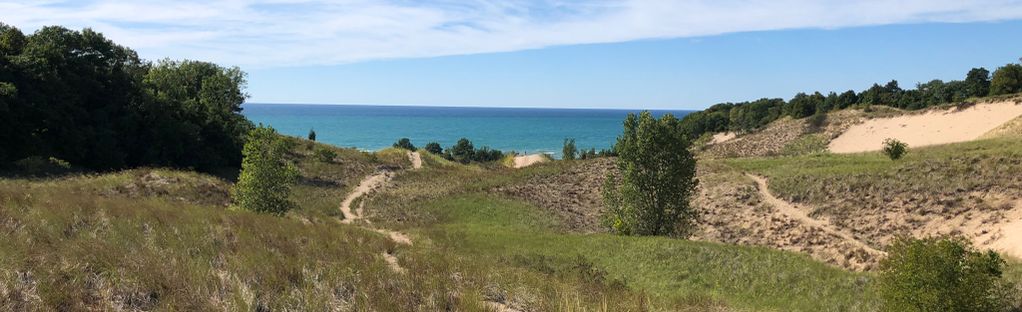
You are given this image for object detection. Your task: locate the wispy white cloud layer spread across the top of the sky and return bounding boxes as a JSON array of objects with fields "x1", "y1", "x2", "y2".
[{"x1": 6, "y1": 0, "x2": 1022, "y2": 66}]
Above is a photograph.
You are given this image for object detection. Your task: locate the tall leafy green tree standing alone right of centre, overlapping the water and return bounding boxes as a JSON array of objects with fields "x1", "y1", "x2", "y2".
[{"x1": 603, "y1": 112, "x2": 698, "y2": 236}]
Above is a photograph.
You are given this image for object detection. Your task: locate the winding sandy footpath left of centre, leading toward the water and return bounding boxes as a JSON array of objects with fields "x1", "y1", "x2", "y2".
[{"x1": 340, "y1": 151, "x2": 519, "y2": 312}]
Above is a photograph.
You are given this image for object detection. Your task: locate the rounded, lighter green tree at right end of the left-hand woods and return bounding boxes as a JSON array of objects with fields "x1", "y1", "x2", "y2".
[{"x1": 136, "y1": 59, "x2": 252, "y2": 170}]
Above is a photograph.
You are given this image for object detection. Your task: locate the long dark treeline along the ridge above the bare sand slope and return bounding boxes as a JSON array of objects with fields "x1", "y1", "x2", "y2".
[{"x1": 682, "y1": 60, "x2": 1022, "y2": 137}]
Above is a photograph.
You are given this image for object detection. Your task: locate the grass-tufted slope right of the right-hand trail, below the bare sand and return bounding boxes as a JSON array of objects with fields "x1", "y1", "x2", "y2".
[{"x1": 725, "y1": 137, "x2": 1022, "y2": 250}]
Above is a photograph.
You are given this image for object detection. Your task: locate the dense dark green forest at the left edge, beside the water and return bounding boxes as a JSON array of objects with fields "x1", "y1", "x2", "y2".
[{"x1": 0, "y1": 24, "x2": 252, "y2": 171}]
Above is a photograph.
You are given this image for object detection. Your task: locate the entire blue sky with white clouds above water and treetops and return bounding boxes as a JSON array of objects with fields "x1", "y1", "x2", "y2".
[{"x1": 6, "y1": 0, "x2": 1022, "y2": 108}]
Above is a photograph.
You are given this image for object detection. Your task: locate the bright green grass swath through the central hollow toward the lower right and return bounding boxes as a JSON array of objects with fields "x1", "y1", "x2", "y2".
[{"x1": 367, "y1": 162, "x2": 876, "y2": 311}]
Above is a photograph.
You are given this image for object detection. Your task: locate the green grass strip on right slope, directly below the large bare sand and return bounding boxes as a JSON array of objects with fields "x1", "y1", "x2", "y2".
[{"x1": 725, "y1": 137, "x2": 1022, "y2": 204}]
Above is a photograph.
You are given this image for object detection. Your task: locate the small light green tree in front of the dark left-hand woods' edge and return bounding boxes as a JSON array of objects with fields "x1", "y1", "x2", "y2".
[{"x1": 231, "y1": 125, "x2": 298, "y2": 215}]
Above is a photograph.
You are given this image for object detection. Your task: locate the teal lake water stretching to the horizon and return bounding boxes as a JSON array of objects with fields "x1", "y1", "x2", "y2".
[{"x1": 242, "y1": 103, "x2": 691, "y2": 158}]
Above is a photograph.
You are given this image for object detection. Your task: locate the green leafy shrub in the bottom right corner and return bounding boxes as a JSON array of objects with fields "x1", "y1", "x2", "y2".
[{"x1": 877, "y1": 237, "x2": 1013, "y2": 311}]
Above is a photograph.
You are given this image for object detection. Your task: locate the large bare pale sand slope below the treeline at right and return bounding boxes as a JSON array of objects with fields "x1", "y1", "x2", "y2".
[{"x1": 829, "y1": 101, "x2": 1022, "y2": 152}]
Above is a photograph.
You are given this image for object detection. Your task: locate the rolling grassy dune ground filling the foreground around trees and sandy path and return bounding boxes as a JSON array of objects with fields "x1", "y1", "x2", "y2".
[{"x1": 0, "y1": 125, "x2": 1022, "y2": 311}]
